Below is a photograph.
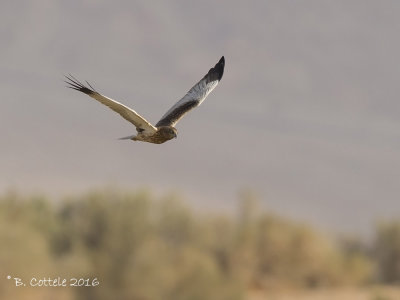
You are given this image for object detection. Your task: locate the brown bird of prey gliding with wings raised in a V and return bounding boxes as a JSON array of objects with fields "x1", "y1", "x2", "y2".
[{"x1": 65, "y1": 56, "x2": 225, "y2": 144}]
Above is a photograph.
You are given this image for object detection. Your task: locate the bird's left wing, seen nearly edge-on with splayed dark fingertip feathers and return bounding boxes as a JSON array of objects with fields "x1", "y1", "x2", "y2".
[{"x1": 65, "y1": 74, "x2": 157, "y2": 134}]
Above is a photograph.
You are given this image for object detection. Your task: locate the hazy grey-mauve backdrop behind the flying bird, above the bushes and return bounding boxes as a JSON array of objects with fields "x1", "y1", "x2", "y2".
[{"x1": 0, "y1": 0, "x2": 400, "y2": 232}]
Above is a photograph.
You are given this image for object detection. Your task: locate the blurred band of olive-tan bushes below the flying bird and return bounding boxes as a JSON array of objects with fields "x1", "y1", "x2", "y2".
[{"x1": 0, "y1": 191, "x2": 400, "y2": 300}]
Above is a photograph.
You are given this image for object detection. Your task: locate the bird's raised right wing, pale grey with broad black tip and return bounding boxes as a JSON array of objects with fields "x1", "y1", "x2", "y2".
[{"x1": 156, "y1": 56, "x2": 225, "y2": 127}]
